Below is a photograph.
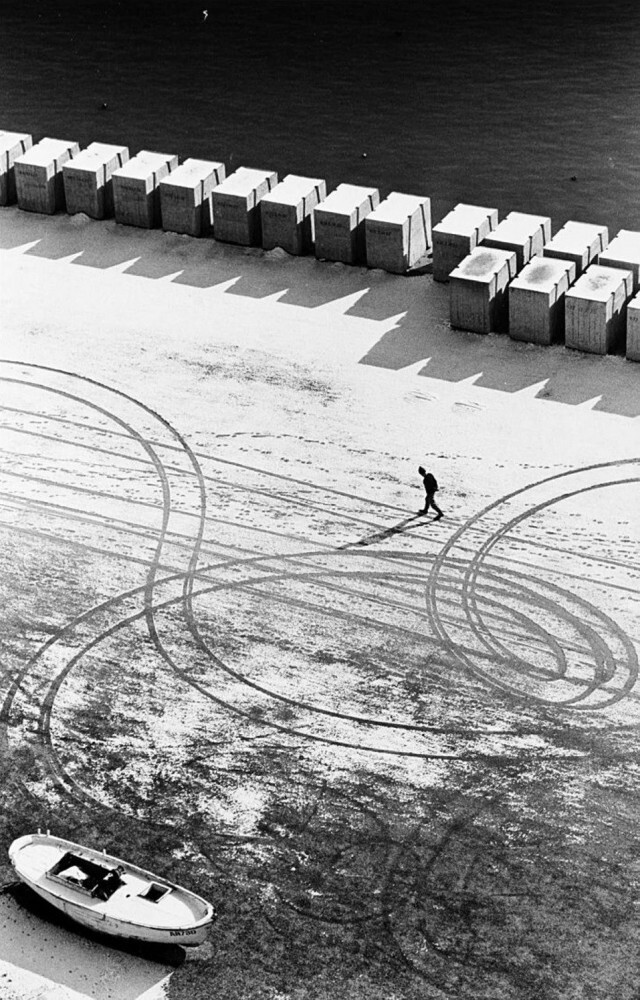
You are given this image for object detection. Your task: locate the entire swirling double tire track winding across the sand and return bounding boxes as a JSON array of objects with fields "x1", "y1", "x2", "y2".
[{"x1": 5, "y1": 362, "x2": 637, "y2": 828}]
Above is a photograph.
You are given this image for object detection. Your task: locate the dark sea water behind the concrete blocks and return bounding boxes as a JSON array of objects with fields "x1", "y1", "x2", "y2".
[{"x1": 0, "y1": 0, "x2": 640, "y2": 235}]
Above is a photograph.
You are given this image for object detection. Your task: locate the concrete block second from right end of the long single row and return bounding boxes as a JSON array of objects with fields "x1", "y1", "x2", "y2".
[{"x1": 313, "y1": 184, "x2": 380, "y2": 264}]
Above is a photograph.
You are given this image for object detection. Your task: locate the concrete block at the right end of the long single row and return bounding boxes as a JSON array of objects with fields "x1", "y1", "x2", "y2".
[{"x1": 364, "y1": 191, "x2": 431, "y2": 274}]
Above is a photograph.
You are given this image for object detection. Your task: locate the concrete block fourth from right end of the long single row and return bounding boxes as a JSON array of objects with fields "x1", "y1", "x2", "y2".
[{"x1": 213, "y1": 167, "x2": 278, "y2": 246}]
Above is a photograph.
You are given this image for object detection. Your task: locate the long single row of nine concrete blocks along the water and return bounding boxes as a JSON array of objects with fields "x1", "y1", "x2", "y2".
[{"x1": 0, "y1": 132, "x2": 431, "y2": 273}]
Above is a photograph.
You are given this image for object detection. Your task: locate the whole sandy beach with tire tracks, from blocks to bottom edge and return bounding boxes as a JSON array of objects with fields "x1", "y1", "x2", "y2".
[{"x1": 0, "y1": 208, "x2": 640, "y2": 1000}]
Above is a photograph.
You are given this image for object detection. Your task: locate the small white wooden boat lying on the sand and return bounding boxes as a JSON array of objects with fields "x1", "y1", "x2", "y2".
[{"x1": 9, "y1": 832, "x2": 215, "y2": 946}]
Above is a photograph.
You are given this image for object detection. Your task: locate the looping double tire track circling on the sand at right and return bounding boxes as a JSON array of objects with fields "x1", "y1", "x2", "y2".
[{"x1": 426, "y1": 459, "x2": 640, "y2": 709}]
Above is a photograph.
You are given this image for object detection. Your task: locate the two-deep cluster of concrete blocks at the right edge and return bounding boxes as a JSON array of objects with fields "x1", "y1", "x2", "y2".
[{"x1": 442, "y1": 206, "x2": 640, "y2": 361}]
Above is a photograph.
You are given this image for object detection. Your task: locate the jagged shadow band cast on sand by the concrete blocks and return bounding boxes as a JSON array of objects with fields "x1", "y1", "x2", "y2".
[{"x1": 0, "y1": 206, "x2": 640, "y2": 416}]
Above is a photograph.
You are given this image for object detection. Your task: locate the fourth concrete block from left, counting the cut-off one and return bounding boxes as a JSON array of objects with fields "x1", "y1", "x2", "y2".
[{"x1": 112, "y1": 149, "x2": 178, "y2": 229}]
